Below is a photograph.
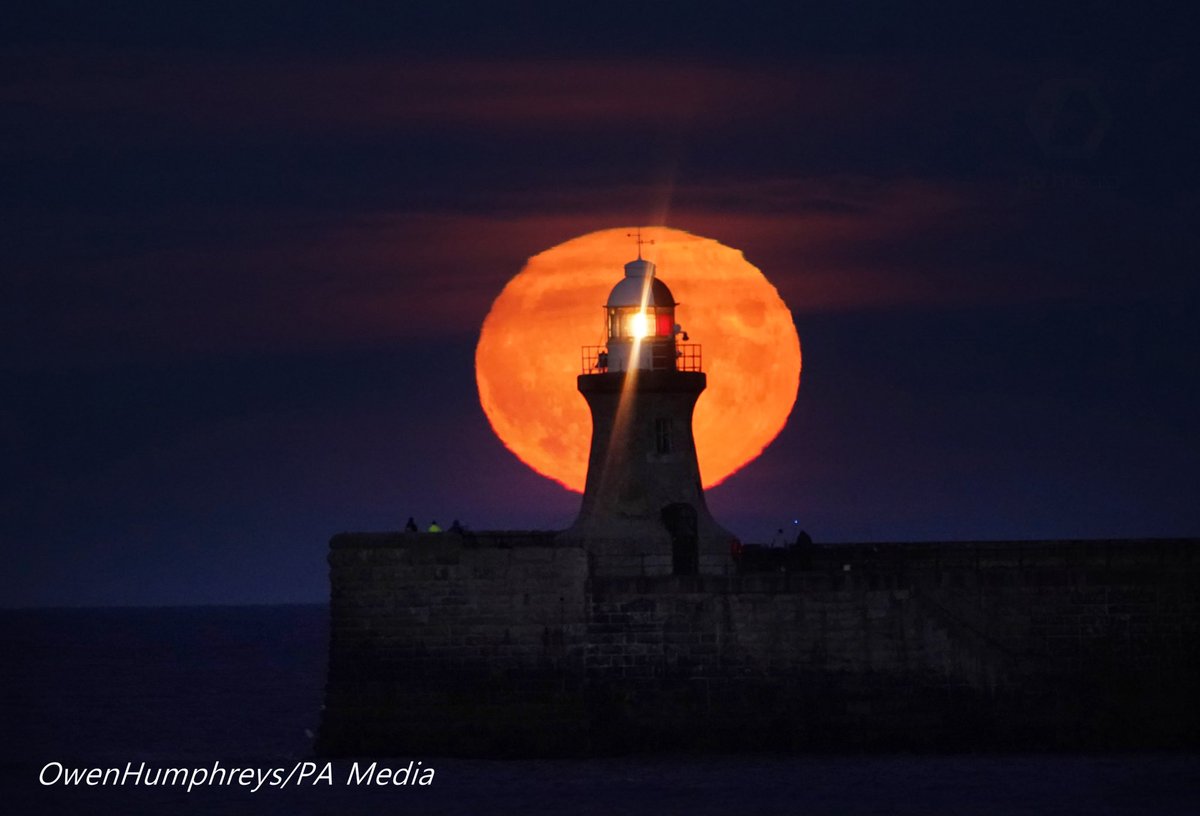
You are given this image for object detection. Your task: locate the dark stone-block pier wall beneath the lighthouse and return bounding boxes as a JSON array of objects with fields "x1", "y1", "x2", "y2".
[{"x1": 318, "y1": 533, "x2": 1200, "y2": 756}]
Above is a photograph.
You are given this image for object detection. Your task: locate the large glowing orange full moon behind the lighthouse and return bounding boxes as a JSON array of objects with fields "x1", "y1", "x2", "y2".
[{"x1": 475, "y1": 227, "x2": 800, "y2": 492}]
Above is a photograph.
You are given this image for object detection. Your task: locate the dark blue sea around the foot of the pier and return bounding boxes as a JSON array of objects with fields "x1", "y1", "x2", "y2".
[{"x1": 0, "y1": 605, "x2": 1200, "y2": 816}]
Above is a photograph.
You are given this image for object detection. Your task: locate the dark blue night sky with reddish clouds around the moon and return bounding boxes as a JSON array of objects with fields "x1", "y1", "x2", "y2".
[{"x1": 0, "y1": 2, "x2": 1200, "y2": 606}]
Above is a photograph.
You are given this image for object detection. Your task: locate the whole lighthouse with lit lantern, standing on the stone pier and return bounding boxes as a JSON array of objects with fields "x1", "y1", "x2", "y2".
[{"x1": 560, "y1": 241, "x2": 736, "y2": 575}]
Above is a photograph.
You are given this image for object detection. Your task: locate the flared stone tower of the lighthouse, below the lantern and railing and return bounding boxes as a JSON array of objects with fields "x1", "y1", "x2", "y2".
[{"x1": 558, "y1": 370, "x2": 736, "y2": 575}]
